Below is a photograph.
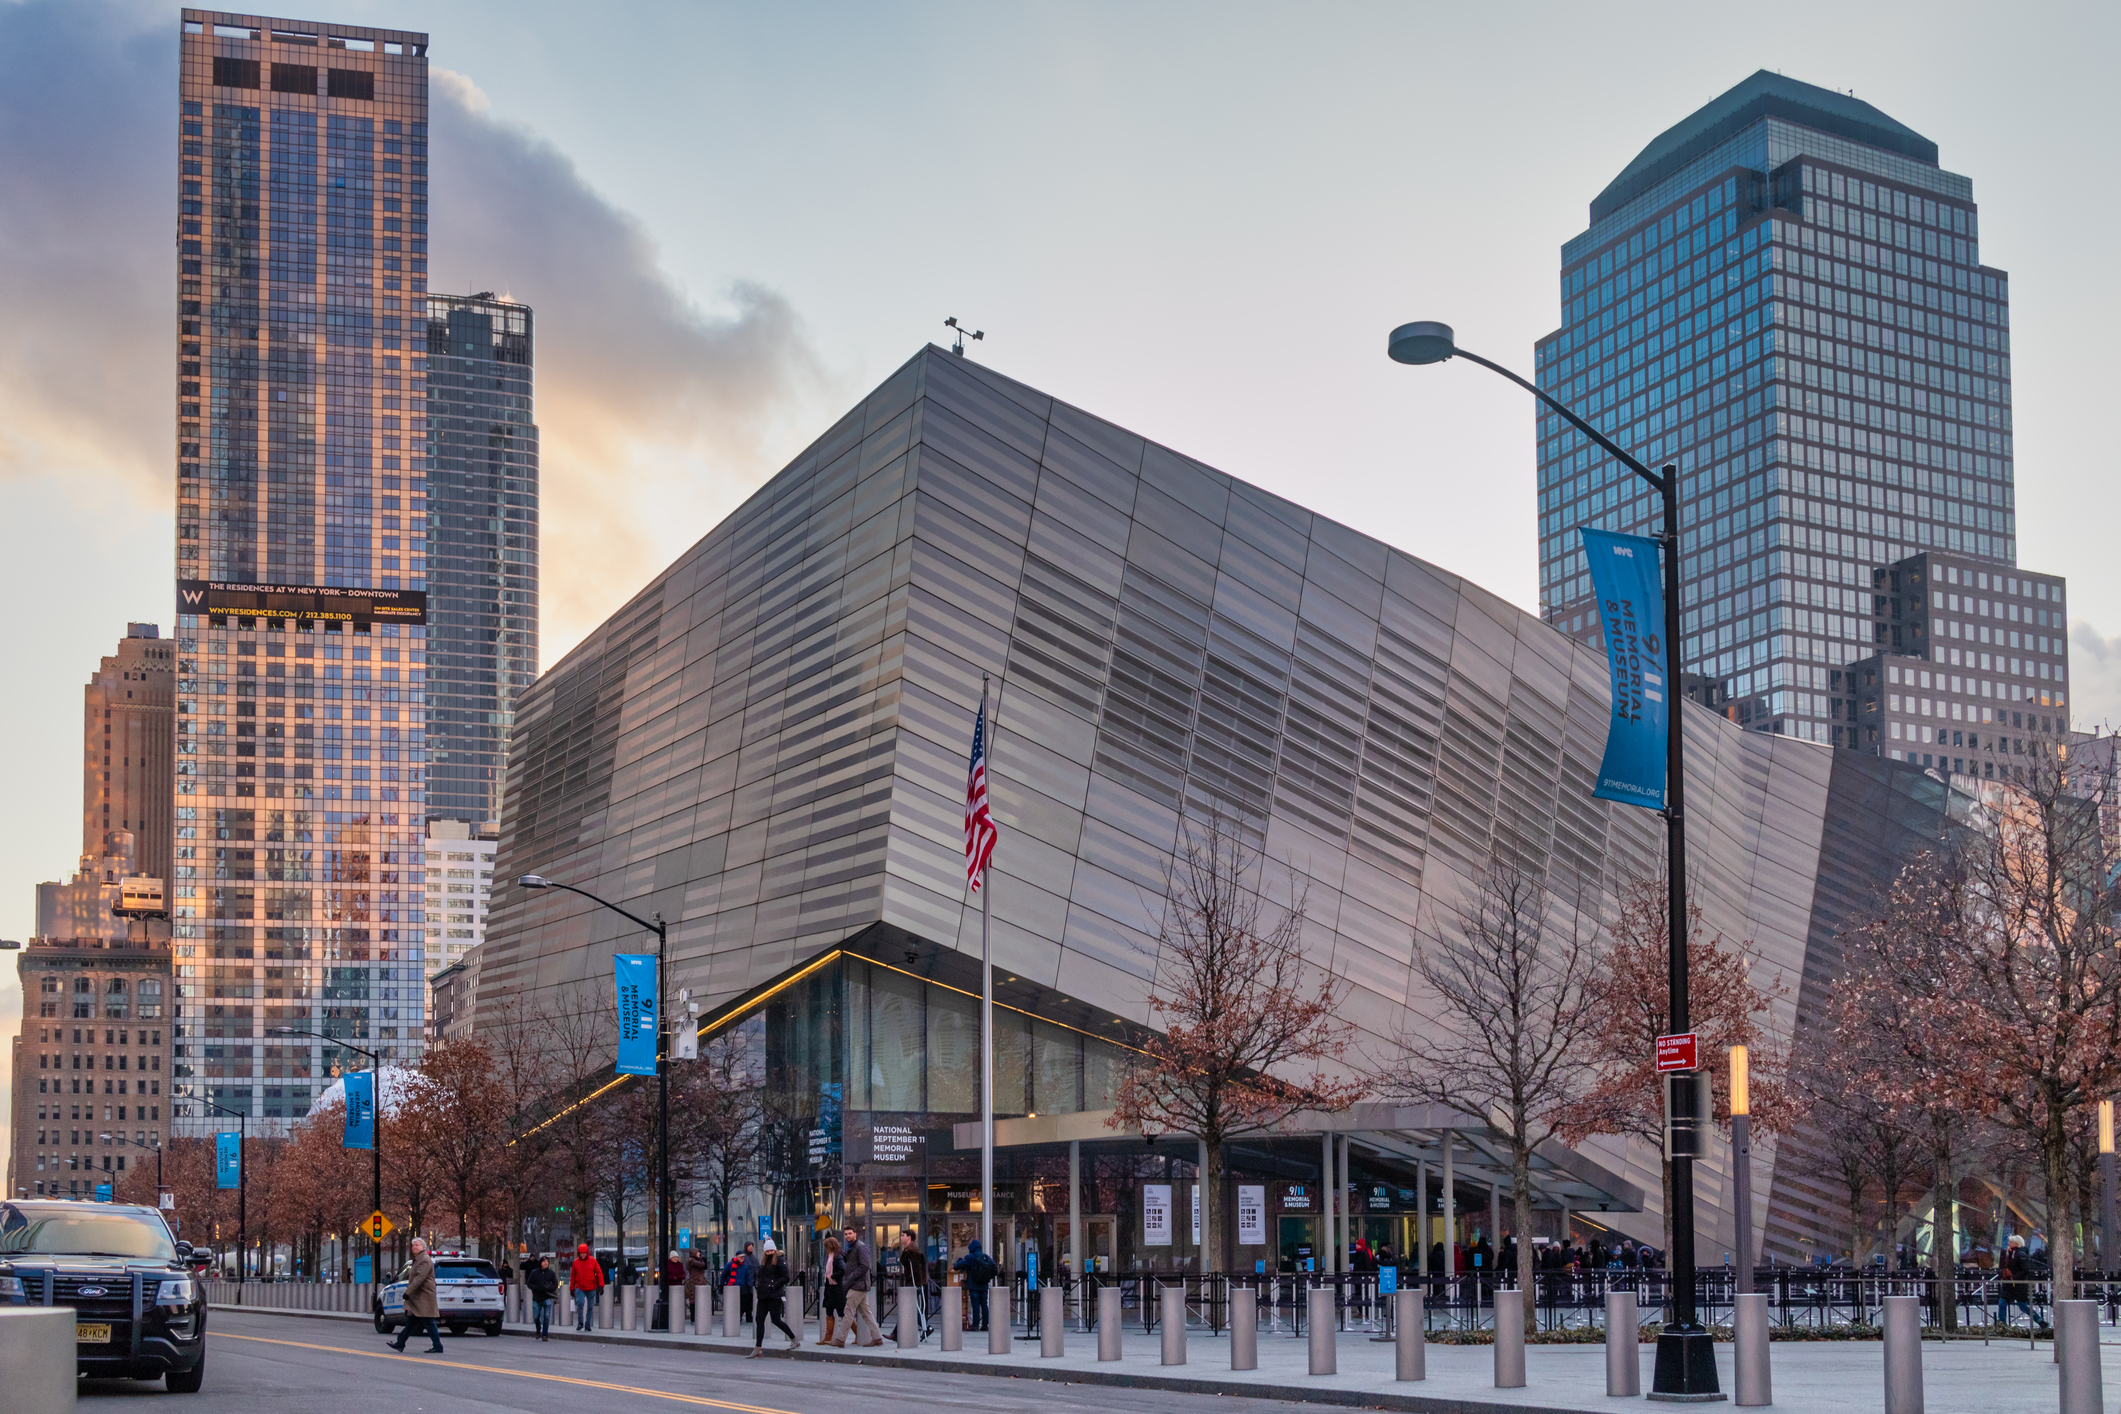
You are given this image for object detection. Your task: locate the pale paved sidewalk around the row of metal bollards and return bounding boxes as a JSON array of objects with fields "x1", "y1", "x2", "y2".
[{"x1": 219, "y1": 1308, "x2": 2121, "y2": 1414}]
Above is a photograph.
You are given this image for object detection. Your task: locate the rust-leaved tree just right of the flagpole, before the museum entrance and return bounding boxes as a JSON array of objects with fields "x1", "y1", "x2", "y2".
[{"x1": 1107, "y1": 816, "x2": 1364, "y2": 1270}]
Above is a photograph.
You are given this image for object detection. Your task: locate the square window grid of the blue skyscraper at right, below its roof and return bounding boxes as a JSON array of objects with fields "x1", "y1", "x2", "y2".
[{"x1": 1536, "y1": 146, "x2": 2044, "y2": 740}]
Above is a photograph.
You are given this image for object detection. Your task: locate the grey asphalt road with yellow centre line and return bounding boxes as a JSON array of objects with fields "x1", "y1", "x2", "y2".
[{"x1": 81, "y1": 1310, "x2": 1323, "y2": 1414}]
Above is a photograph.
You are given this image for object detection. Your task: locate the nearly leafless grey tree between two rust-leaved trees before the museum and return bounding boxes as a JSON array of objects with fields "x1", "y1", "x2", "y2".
[{"x1": 1383, "y1": 856, "x2": 1603, "y2": 1329}]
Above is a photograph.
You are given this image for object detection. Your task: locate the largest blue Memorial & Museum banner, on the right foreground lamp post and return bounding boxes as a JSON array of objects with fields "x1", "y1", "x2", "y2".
[{"x1": 1582, "y1": 526, "x2": 1671, "y2": 810}]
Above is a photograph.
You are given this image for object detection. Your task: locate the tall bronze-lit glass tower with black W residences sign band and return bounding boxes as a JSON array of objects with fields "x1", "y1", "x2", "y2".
[{"x1": 172, "y1": 11, "x2": 426, "y2": 1132}]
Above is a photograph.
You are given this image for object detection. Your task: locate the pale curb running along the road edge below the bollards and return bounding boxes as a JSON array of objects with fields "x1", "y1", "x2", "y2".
[{"x1": 210, "y1": 1304, "x2": 1582, "y2": 1414}]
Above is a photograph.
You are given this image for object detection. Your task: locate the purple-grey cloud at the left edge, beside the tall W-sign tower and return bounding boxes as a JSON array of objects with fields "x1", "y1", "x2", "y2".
[{"x1": 0, "y1": 4, "x2": 176, "y2": 500}]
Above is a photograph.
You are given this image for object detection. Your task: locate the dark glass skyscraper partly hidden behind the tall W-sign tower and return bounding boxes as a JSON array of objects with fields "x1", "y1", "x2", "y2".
[{"x1": 426, "y1": 293, "x2": 537, "y2": 831}]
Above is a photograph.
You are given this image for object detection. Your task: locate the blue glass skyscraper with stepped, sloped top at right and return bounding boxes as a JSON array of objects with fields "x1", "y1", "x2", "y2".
[{"x1": 1536, "y1": 72, "x2": 2023, "y2": 746}]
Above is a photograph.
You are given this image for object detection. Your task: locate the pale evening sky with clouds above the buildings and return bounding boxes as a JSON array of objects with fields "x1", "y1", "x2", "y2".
[{"x1": 0, "y1": 0, "x2": 2121, "y2": 1161}]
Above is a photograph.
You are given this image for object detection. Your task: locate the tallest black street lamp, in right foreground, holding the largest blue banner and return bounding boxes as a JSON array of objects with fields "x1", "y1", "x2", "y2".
[{"x1": 1387, "y1": 320, "x2": 1716, "y2": 1395}]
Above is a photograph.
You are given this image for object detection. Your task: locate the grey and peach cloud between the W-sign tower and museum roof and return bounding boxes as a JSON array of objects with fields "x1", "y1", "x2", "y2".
[{"x1": 428, "y1": 70, "x2": 821, "y2": 666}]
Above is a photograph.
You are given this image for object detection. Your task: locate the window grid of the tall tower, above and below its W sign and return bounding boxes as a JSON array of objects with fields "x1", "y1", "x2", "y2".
[{"x1": 172, "y1": 28, "x2": 426, "y2": 1117}]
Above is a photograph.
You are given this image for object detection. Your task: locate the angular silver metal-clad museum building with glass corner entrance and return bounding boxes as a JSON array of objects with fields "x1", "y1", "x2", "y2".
[{"x1": 477, "y1": 348, "x2": 1956, "y2": 1270}]
